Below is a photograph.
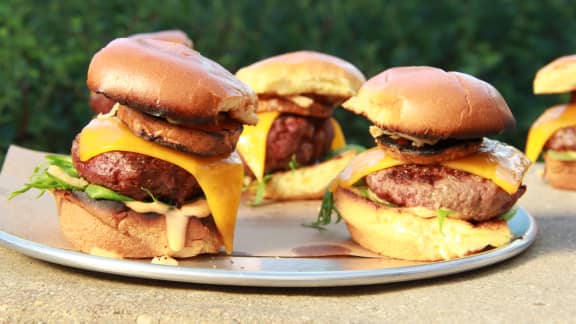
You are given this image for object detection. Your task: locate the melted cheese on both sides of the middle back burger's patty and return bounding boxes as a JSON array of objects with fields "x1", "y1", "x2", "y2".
[{"x1": 236, "y1": 111, "x2": 346, "y2": 181}]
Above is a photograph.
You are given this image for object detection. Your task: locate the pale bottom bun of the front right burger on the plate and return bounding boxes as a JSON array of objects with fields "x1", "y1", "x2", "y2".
[{"x1": 334, "y1": 187, "x2": 513, "y2": 261}]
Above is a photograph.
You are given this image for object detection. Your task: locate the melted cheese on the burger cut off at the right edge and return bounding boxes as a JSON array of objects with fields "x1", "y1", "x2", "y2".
[{"x1": 526, "y1": 104, "x2": 576, "y2": 162}]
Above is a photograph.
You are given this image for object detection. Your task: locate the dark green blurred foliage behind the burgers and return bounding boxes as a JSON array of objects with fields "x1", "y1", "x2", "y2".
[{"x1": 0, "y1": 0, "x2": 576, "y2": 162}]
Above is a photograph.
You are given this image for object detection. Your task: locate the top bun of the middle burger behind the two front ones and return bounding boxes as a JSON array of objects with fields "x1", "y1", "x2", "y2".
[{"x1": 236, "y1": 51, "x2": 365, "y2": 97}]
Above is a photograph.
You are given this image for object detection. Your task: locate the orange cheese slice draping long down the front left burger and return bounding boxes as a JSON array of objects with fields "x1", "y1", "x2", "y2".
[{"x1": 78, "y1": 115, "x2": 244, "y2": 253}]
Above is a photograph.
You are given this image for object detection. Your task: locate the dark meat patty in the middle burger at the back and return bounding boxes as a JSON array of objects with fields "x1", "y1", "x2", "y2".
[{"x1": 265, "y1": 114, "x2": 334, "y2": 172}]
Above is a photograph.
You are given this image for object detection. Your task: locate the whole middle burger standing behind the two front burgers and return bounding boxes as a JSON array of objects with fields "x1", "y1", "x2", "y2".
[{"x1": 236, "y1": 51, "x2": 365, "y2": 203}]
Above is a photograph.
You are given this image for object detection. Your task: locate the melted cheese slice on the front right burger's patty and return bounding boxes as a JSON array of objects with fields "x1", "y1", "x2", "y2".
[{"x1": 338, "y1": 138, "x2": 530, "y2": 194}]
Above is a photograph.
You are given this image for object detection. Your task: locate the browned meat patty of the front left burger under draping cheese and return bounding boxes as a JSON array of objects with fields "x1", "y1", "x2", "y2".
[{"x1": 71, "y1": 138, "x2": 202, "y2": 206}]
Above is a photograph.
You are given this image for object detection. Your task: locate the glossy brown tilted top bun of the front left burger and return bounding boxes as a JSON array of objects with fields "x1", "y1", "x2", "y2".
[{"x1": 87, "y1": 38, "x2": 257, "y2": 125}]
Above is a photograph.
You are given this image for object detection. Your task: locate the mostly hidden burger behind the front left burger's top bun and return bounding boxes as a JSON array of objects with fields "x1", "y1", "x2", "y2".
[{"x1": 89, "y1": 29, "x2": 194, "y2": 114}]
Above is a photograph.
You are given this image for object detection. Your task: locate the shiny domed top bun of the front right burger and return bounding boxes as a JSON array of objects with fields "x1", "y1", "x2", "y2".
[{"x1": 342, "y1": 66, "x2": 515, "y2": 139}]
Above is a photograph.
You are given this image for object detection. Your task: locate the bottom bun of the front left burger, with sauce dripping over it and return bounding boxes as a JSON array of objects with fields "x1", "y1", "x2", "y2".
[{"x1": 52, "y1": 190, "x2": 223, "y2": 258}]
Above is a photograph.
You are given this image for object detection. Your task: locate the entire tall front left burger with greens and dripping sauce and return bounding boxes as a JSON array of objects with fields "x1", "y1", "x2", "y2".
[{"x1": 12, "y1": 38, "x2": 257, "y2": 258}]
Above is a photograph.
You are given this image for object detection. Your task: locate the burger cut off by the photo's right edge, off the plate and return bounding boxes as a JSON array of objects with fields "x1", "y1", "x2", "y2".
[{"x1": 526, "y1": 55, "x2": 576, "y2": 190}]
